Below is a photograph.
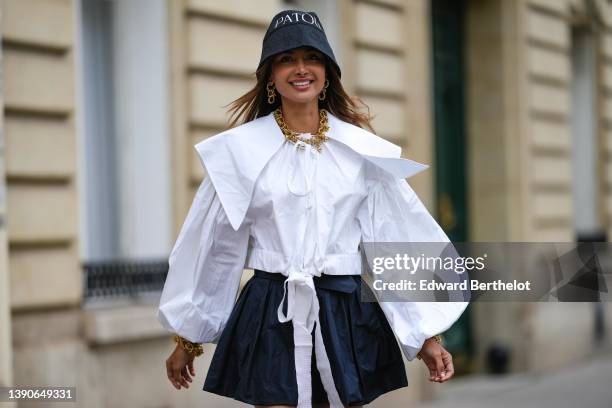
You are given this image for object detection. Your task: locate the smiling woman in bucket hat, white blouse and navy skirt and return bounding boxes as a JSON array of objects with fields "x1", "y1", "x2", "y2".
[{"x1": 159, "y1": 10, "x2": 467, "y2": 408}]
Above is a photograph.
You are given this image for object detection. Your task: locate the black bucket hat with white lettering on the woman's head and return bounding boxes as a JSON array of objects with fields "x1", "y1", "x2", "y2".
[{"x1": 257, "y1": 10, "x2": 341, "y2": 76}]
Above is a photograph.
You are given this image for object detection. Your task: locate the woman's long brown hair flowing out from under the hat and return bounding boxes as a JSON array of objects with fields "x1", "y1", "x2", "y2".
[{"x1": 226, "y1": 56, "x2": 374, "y2": 132}]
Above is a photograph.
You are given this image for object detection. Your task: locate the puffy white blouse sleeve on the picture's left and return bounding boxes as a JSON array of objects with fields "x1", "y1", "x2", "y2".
[{"x1": 157, "y1": 177, "x2": 249, "y2": 343}]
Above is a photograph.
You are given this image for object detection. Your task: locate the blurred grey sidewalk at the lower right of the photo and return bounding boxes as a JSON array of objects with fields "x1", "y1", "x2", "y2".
[{"x1": 414, "y1": 354, "x2": 612, "y2": 408}]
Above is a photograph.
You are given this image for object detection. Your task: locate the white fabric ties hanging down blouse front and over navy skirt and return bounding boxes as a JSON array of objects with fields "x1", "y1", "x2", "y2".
[{"x1": 278, "y1": 142, "x2": 344, "y2": 408}]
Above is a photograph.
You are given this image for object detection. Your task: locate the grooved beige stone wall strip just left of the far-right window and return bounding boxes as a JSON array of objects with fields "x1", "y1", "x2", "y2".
[{"x1": 522, "y1": 0, "x2": 574, "y2": 241}]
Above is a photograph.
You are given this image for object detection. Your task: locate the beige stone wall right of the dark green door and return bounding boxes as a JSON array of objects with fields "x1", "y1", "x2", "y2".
[{"x1": 467, "y1": 0, "x2": 612, "y2": 370}]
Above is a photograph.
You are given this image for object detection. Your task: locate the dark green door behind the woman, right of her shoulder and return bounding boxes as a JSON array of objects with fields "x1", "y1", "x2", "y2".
[{"x1": 431, "y1": 0, "x2": 473, "y2": 374}]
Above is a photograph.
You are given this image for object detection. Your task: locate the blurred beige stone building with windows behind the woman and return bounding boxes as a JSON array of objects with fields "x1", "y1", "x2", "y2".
[{"x1": 0, "y1": 0, "x2": 612, "y2": 408}]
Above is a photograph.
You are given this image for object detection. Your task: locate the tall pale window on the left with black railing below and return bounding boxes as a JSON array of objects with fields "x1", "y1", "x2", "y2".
[{"x1": 79, "y1": 0, "x2": 172, "y2": 297}]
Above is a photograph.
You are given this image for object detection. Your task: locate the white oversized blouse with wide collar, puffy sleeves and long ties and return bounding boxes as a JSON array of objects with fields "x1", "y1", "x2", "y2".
[{"x1": 158, "y1": 110, "x2": 467, "y2": 407}]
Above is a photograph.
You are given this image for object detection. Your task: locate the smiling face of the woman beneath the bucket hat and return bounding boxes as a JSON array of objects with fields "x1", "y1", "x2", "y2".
[{"x1": 270, "y1": 47, "x2": 325, "y2": 104}]
